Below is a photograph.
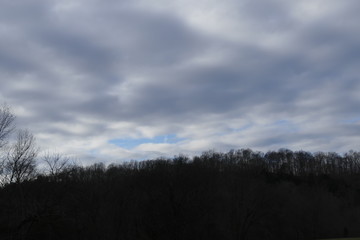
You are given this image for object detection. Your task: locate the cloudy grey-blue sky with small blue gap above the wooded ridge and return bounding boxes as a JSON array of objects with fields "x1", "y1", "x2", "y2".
[{"x1": 0, "y1": 0, "x2": 360, "y2": 164}]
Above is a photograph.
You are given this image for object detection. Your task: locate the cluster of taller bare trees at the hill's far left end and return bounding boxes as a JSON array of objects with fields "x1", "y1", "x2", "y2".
[{"x1": 0, "y1": 104, "x2": 73, "y2": 186}]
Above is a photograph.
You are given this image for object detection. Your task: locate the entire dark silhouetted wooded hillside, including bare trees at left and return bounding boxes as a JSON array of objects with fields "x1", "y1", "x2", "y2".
[{"x1": 0, "y1": 104, "x2": 360, "y2": 240}]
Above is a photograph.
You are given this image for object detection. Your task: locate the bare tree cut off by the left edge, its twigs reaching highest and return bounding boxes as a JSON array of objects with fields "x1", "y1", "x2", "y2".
[{"x1": 0, "y1": 104, "x2": 15, "y2": 148}]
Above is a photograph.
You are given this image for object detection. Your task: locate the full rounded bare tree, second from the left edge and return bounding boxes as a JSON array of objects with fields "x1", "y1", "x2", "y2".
[{"x1": 3, "y1": 130, "x2": 39, "y2": 183}]
